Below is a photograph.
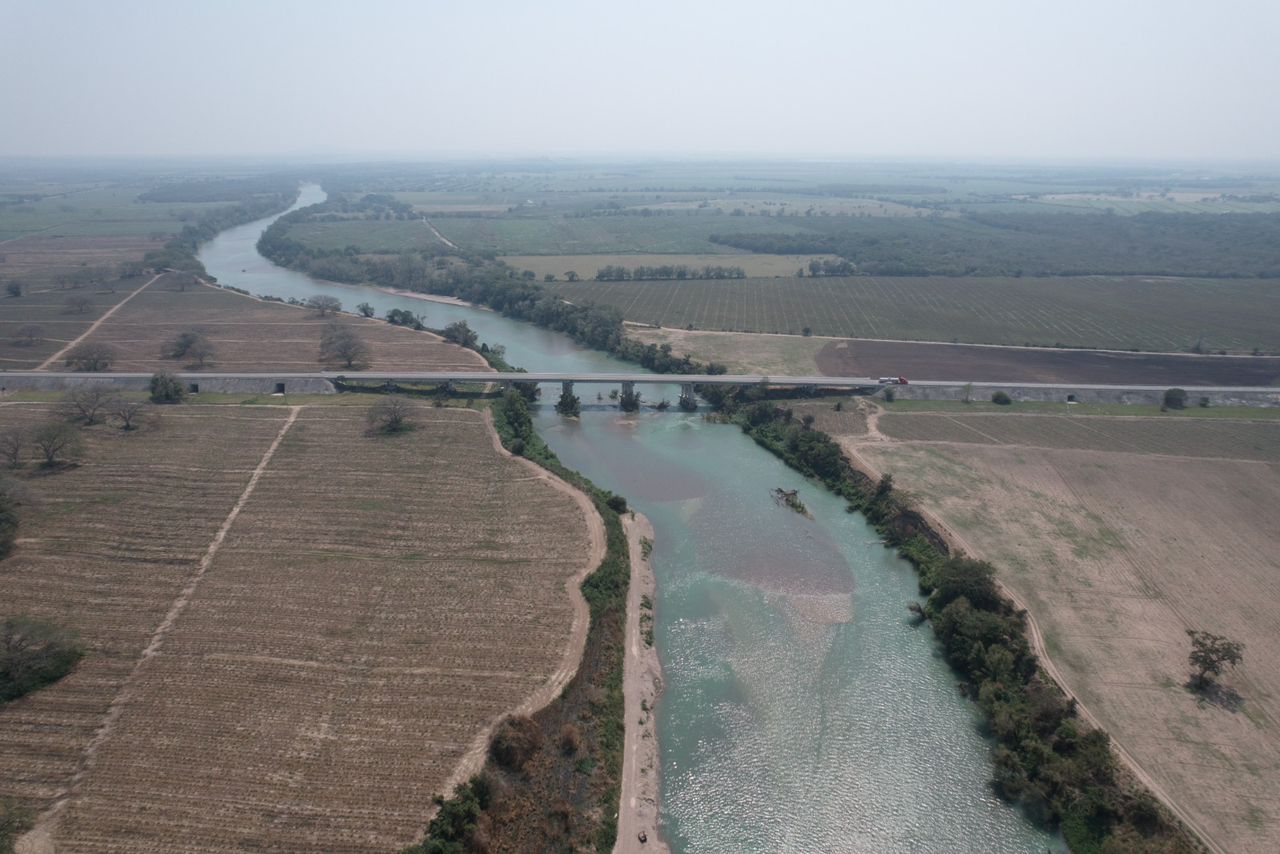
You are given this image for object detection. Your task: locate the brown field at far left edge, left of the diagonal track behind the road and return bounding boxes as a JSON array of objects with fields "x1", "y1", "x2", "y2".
[{"x1": 0, "y1": 236, "x2": 156, "y2": 370}]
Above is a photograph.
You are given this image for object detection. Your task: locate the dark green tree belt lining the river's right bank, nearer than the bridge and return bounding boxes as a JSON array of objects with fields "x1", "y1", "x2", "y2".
[{"x1": 724, "y1": 398, "x2": 1201, "y2": 854}]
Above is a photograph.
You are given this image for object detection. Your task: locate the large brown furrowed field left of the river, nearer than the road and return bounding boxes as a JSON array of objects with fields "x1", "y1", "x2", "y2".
[{"x1": 0, "y1": 403, "x2": 590, "y2": 851}]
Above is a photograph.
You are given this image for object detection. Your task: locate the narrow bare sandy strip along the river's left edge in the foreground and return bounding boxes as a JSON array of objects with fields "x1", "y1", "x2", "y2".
[{"x1": 613, "y1": 513, "x2": 671, "y2": 854}]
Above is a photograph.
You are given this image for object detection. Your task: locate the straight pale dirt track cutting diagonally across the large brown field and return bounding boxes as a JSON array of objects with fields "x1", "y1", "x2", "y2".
[{"x1": 15, "y1": 407, "x2": 302, "y2": 854}]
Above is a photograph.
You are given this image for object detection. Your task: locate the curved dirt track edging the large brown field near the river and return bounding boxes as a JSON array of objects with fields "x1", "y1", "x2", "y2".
[{"x1": 428, "y1": 410, "x2": 607, "y2": 798}]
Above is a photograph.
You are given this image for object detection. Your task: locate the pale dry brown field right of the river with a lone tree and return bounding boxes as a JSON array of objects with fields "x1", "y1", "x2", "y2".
[{"x1": 819, "y1": 405, "x2": 1280, "y2": 853}]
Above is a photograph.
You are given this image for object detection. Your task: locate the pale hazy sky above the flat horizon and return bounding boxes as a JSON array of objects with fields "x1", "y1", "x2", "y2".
[{"x1": 0, "y1": 0, "x2": 1280, "y2": 160}]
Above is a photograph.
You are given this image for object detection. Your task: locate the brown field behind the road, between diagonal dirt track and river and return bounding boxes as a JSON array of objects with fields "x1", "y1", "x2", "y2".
[{"x1": 50, "y1": 275, "x2": 490, "y2": 371}]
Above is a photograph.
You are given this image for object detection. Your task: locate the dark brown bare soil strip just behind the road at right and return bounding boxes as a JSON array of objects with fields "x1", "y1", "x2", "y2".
[{"x1": 817, "y1": 339, "x2": 1280, "y2": 385}]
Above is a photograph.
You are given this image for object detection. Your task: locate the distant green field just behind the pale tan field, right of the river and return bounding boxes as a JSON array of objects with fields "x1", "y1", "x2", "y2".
[{"x1": 431, "y1": 214, "x2": 806, "y2": 255}]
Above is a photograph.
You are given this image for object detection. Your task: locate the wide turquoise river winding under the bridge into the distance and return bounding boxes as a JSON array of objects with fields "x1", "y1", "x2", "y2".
[{"x1": 200, "y1": 184, "x2": 1065, "y2": 853}]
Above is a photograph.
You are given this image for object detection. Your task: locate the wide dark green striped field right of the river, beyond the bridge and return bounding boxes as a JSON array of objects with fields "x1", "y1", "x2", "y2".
[{"x1": 548, "y1": 277, "x2": 1280, "y2": 352}]
